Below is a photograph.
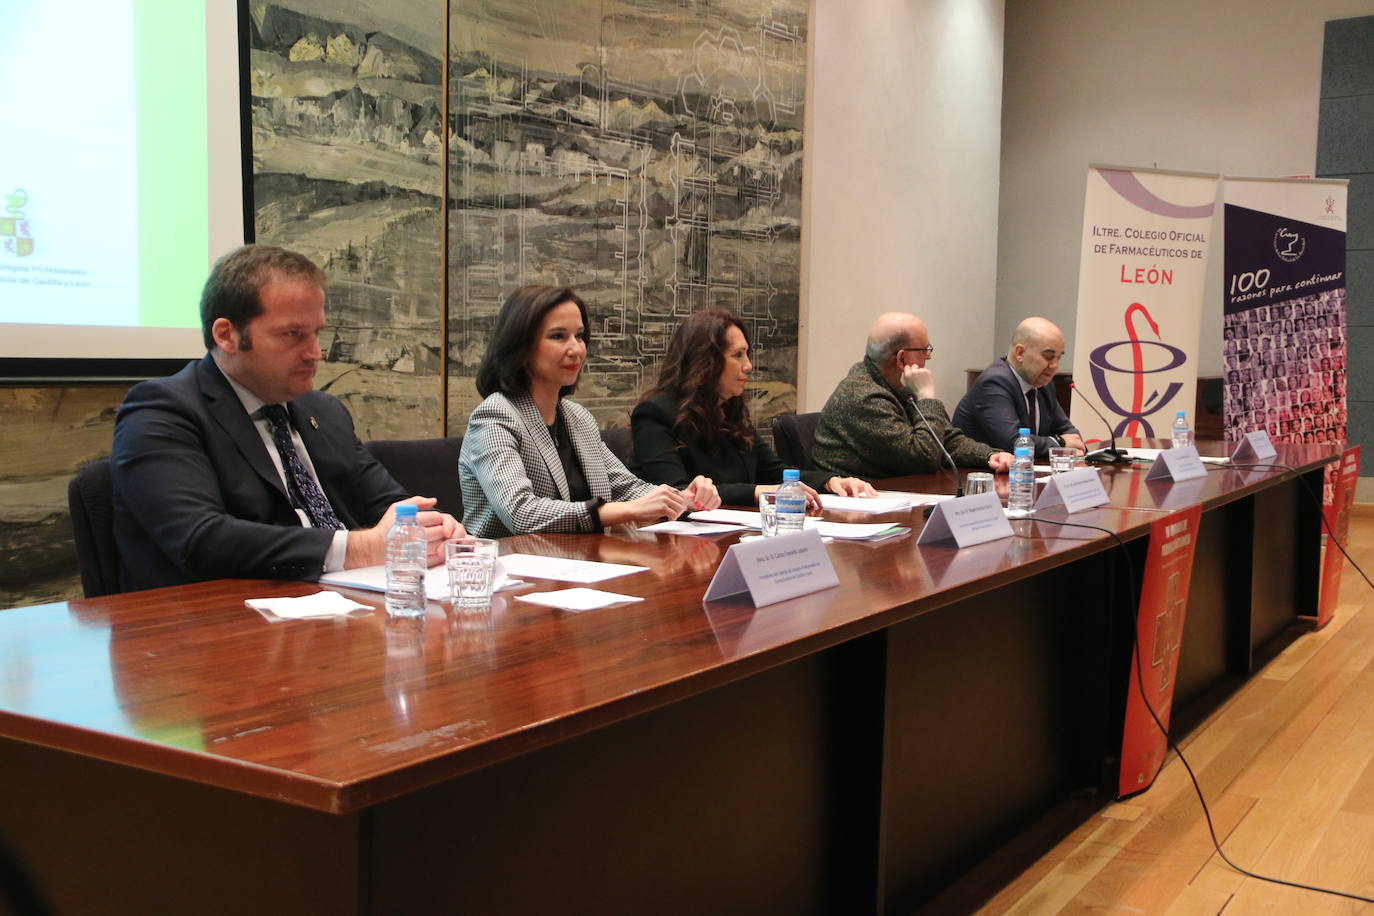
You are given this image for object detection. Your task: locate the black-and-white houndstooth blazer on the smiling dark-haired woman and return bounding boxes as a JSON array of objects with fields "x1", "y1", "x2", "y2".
[{"x1": 458, "y1": 393, "x2": 654, "y2": 537}]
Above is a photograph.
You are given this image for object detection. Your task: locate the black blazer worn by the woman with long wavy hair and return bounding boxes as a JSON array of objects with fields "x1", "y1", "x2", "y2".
[{"x1": 629, "y1": 394, "x2": 835, "y2": 505}]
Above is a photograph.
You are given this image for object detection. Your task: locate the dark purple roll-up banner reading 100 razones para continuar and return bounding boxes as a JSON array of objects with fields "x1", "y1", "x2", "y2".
[{"x1": 1221, "y1": 177, "x2": 1347, "y2": 445}]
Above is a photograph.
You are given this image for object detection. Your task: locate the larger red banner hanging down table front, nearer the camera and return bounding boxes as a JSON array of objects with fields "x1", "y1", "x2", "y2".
[{"x1": 1117, "y1": 504, "x2": 1202, "y2": 798}]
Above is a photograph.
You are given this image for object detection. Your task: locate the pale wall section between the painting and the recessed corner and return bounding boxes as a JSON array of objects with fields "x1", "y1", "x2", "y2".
[{"x1": 798, "y1": 0, "x2": 1003, "y2": 411}]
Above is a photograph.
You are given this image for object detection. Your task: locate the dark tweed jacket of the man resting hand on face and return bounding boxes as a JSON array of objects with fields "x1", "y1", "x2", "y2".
[{"x1": 813, "y1": 357, "x2": 996, "y2": 479}]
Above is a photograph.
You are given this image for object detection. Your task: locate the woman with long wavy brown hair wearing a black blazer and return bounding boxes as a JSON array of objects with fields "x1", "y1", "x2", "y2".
[{"x1": 629, "y1": 309, "x2": 874, "y2": 507}]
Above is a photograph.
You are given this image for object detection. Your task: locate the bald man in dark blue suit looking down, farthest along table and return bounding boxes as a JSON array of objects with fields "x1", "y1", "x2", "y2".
[{"x1": 954, "y1": 319, "x2": 1087, "y2": 459}]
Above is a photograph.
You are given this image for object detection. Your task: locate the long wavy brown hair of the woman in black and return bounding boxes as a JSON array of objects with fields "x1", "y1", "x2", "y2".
[{"x1": 644, "y1": 309, "x2": 754, "y2": 450}]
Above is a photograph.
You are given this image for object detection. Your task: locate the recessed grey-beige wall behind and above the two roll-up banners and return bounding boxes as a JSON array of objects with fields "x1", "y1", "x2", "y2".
[{"x1": 996, "y1": 0, "x2": 1374, "y2": 372}]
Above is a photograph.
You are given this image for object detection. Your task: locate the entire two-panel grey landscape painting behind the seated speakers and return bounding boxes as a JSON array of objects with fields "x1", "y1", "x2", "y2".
[{"x1": 249, "y1": 0, "x2": 807, "y2": 438}]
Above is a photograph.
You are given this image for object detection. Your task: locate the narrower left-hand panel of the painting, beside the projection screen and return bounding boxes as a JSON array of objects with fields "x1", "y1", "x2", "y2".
[{"x1": 249, "y1": 0, "x2": 445, "y2": 439}]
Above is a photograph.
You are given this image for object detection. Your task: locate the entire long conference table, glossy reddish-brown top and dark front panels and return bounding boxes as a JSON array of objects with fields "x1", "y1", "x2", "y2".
[{"x1": 0, "y1": 446, "x2": 1337, "y2": 913}]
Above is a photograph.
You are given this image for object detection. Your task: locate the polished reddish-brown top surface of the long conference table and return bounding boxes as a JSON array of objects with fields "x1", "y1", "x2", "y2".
[{"x1": 0, "y1": 444, "x2": 1338, "y2": 813}]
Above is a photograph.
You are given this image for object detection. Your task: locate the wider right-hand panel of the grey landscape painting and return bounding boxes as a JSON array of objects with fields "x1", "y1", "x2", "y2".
[{"x1": 448, "y1": 0, "x2": 807, "y2": 434}]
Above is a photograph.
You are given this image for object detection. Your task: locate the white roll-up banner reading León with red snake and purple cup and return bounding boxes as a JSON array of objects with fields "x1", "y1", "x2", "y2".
[{"x1": 1070, "y1": 165, "x2": 1217, "y2": 438}]
